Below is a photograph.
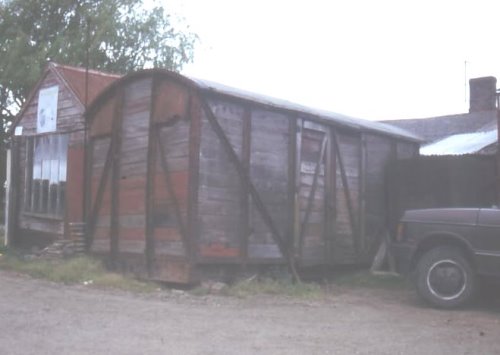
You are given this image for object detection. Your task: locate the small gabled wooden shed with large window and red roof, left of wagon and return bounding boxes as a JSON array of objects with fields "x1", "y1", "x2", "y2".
[{"x1": 9, "y1": 63, "x2": 119, "y2": 247}]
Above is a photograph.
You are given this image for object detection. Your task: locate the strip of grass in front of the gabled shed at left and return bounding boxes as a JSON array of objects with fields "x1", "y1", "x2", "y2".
[{"x1": 0, "y1": 252, "x2": 157, "y2": 292}]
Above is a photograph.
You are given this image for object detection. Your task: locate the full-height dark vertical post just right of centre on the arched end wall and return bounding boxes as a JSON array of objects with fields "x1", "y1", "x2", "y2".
[{"x1": 144, "y1": 77, "x2": 159, "y2": 277}]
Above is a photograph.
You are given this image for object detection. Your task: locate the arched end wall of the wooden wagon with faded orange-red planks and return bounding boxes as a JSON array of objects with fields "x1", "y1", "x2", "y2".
[{"x1": 89, "y1": 78, "x2": 190, "y2": 281}]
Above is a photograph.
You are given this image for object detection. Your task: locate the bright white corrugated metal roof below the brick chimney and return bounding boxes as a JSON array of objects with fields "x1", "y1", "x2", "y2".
[{"x1": 420, "y1": 129, "x2": 498, "y2": 155}]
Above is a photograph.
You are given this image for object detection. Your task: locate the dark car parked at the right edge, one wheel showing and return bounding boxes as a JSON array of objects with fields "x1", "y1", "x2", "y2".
[{"x1": 391, "y1": 208, "x2": 500, "y2": 308}]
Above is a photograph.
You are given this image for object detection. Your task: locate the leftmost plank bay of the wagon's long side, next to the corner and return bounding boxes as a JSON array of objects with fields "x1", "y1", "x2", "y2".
[{"x1": 198, "y1": 101, "x2": 244, "y2": 258}]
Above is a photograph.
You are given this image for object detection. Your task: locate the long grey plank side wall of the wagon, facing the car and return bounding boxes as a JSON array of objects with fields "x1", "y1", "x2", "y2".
[{"x1": 198, "y1": 94, "x2": 418, "y2": 265}]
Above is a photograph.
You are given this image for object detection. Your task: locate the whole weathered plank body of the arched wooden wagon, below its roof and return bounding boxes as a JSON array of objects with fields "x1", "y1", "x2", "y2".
[{"x1": 83, "y1": 70, "x2": 418, "y2": 282}]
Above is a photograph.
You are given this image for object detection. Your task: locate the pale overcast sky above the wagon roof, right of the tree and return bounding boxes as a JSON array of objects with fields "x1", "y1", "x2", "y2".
[{"x1": 162, "y1": 0, "x2": 500, "y2": 119}]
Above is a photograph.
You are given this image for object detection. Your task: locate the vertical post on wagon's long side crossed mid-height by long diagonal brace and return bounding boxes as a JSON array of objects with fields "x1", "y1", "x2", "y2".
[{"x1": 240, "y1": 106, "x2": 252, "y2": 264}]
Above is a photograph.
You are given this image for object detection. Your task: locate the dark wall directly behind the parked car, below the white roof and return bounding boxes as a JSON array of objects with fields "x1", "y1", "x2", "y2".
[{"x1": 388, "y1": 155, "x2": 497, "y2": 229}]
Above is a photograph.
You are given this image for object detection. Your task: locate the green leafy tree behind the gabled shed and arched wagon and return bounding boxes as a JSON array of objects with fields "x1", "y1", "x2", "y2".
[{"x1": 0, "y1": 0, "x2": 196, "y2": 129}]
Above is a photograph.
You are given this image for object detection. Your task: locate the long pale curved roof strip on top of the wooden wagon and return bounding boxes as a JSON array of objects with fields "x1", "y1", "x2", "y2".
[{"x1": 189, "y1": 78, "x2": 422, "y2": 142}]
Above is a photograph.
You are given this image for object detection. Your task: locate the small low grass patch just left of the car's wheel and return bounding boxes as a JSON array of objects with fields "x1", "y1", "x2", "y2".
[{"x1": 332, "y1": 270, "x2": 410, "y2": 289}]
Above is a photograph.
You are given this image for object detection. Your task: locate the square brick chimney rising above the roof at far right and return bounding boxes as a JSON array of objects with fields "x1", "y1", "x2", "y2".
[{"x1": 469, "y1": 76, "x2": 497, "y2": 112}]
